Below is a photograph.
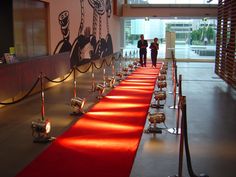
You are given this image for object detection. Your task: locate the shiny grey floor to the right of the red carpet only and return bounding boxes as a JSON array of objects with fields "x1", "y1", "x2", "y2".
[{"x1": 130, "y1": 63, "x2": 236, "y2": 177}]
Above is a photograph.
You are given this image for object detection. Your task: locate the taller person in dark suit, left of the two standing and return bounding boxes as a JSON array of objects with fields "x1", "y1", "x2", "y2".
[{"x1": 137, "y1": 34, "x2": 148, "y2": 67}]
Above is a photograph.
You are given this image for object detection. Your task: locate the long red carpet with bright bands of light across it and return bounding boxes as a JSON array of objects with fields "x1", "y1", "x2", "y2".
[{"x1": 17, "y1": 64, "x2": 161, "y2": 177}]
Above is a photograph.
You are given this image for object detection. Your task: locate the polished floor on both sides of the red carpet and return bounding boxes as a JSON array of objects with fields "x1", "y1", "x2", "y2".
[{"x1": 0, "y1": 59, "x2": 236, "y2": 177}]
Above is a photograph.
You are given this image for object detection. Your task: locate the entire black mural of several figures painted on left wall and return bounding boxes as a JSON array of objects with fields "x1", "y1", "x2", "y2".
[{"x1": 54, "y1": 0, "x2": 113, "y2": 67}]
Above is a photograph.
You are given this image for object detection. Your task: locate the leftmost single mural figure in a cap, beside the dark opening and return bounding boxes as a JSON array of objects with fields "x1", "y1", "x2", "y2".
[{"x1": 53, "y1": 11, "x2": 72, "y2": 54}]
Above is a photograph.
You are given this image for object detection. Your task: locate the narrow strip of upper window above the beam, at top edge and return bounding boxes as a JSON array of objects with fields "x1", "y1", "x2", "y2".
[{"x1": 128, "y1": 0, "x2": 218, "y2": 4}]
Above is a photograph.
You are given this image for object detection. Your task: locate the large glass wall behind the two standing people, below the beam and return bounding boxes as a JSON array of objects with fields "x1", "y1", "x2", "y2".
[{"x1": 121, "y1": 18, "x2": 217, "y2": 59}]
